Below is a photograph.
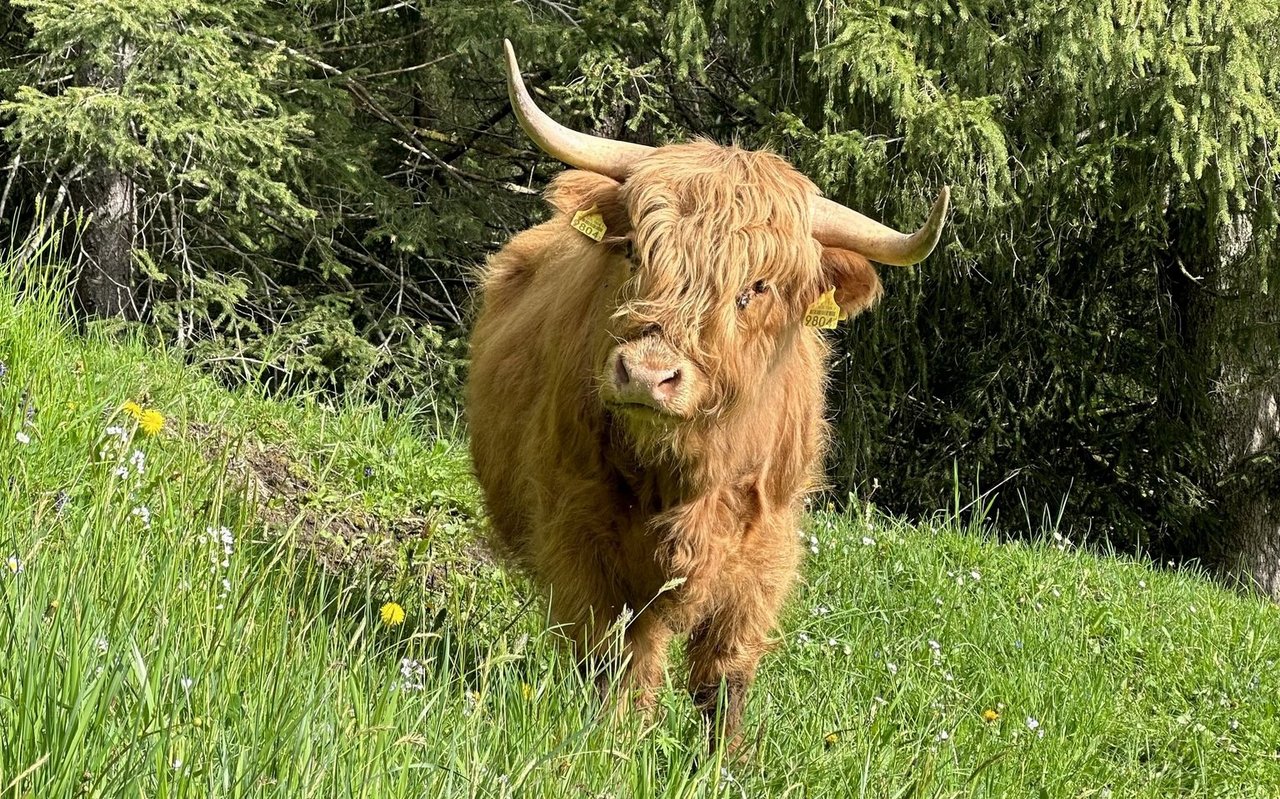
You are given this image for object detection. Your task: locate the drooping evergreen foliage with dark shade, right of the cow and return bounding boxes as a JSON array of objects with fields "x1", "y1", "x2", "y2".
[{"x1": 563, "y1": 1, "x2": 1280, "y2": 556}]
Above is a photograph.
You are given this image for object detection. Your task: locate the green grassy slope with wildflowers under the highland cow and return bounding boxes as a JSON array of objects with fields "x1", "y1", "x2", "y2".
[{"x1": 0, "y1": 271, "x2": 1280, "y2": 798}]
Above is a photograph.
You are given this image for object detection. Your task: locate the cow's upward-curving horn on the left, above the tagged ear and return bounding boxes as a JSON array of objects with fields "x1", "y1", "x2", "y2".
[{"x1": 502, "y1": 38, "x2": 653, "y2": 181}]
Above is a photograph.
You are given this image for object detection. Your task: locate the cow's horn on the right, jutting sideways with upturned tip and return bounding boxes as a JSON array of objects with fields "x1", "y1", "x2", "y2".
[{"x1": 813, "y1": 186, "x2": 951, "y2": 266}]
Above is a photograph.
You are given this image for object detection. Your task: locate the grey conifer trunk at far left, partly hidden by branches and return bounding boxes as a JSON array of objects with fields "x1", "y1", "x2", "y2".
[{"x1": 76, "y1": 36, "x2": 141, "y2": 319}]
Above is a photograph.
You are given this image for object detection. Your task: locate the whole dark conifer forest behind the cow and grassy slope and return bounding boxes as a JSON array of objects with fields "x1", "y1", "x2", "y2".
[{"x1": 0, "y1": 0, "x2": 1280, "y2": 594}]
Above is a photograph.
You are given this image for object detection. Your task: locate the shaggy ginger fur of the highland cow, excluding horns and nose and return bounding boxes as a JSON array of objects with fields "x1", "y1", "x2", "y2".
[{"x1": 467, "y1": 142, "x2": 881, "y2": 735}]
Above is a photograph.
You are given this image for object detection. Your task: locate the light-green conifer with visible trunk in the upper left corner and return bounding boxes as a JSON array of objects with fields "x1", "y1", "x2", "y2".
[{"x1": 0, "y1": 0, "x2": 310, "y2": 316}]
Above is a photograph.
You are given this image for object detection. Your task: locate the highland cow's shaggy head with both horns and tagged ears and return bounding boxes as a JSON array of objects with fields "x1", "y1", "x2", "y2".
[{"x1": 506, "y1": 42, "x2": 947, "y2": 443}]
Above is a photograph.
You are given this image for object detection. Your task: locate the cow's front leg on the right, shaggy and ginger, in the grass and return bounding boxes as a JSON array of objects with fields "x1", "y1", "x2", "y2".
[{"x1": 689, "y1": 576, "x2": 786, "y2": 750}]
